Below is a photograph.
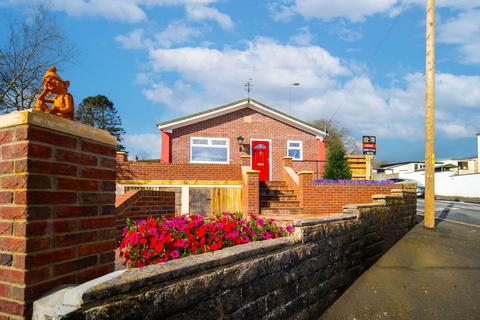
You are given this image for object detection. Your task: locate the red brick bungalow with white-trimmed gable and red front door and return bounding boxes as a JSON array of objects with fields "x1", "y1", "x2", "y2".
[{"x1": 157, "y1": 99, "x2": 326, "y2": 181}]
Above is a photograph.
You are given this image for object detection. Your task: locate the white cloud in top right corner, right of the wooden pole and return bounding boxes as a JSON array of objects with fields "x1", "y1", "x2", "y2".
[{"x1": 438, "y1": 10, "x2": 480, "y2": 64}]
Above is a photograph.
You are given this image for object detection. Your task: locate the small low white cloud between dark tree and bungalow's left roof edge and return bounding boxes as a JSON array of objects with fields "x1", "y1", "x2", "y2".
[{"x1": 124, "y1": 133, "x2": 162, "y2": 159}]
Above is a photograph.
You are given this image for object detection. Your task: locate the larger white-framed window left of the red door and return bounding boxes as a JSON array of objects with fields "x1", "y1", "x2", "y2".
[{"x1": 190, "y1": 137, "x2": 230, "y2": 163}]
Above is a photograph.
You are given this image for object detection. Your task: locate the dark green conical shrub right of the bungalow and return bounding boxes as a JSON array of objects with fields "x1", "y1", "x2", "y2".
[{"x1": 323, "y1": 141, "x2": 352, "y2": 180}]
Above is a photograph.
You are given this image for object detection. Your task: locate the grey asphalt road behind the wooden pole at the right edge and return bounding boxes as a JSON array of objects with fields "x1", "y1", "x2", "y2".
[{"x1": 417, "y1": 198, "x2": 480, "y2": 226}]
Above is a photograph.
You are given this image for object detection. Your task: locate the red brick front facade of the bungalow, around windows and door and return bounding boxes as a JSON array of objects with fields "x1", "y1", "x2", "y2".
[{"x1": 172, "y1": 108, "x2": 319, "y2": 180}]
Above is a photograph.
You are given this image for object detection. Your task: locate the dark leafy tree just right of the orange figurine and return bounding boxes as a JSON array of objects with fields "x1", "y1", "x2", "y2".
[{"x1": 75, "y1": 95, "x2": 125, "y2": 151}]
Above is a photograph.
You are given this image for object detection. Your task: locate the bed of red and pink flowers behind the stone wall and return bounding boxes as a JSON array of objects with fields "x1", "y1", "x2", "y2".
[{"x1": 120, "y1": 212, "x2": 293, "y2": 268}]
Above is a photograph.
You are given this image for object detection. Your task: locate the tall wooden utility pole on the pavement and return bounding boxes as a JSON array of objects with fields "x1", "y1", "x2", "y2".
[{"x1": 424, "y1": 0, "x2": 435, "y2": 228}]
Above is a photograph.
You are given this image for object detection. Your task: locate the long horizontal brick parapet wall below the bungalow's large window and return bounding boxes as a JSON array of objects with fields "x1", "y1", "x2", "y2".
[{"x1": 117, "y1": 158, "x2": 242, "y2": 181}]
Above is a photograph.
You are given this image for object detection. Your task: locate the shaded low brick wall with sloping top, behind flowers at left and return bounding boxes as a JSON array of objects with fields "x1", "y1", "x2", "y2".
[{"x1": 116, "y1": 190, "x2": 175, "y2": 240}]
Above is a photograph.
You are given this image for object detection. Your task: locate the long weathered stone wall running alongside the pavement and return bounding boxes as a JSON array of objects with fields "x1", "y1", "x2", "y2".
[{"x1": 35, "y1": 186, "x2": 416, "y2": 320}]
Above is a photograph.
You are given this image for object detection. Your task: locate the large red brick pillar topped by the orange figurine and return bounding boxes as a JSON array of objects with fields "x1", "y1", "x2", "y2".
[{"x1": 0, "y1": 110, "x2": 116, "y2": 319}]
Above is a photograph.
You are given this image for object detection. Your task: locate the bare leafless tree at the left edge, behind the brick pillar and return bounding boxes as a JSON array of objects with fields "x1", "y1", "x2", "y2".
[{"x1": 0, "y1": 6, "x2": 74, "y2": 113}]
